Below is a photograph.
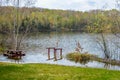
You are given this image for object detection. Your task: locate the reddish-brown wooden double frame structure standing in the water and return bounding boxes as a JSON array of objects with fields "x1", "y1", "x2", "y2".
[{"x1": 47, "y1": 47, "x2": 62, "y2": 61}]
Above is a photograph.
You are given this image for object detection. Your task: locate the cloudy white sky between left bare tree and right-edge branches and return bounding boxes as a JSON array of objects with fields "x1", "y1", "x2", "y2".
[{"x1": 35, "y1": 0, "x2": 116, "y2": 11}]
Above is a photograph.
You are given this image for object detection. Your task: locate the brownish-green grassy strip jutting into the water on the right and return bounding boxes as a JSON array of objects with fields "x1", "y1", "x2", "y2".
[{"x1": 66, "y1": 52, "x2": 120, "y2": 66}]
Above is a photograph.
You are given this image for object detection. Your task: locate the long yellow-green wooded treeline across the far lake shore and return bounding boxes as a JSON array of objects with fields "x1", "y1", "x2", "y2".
[{"x1": 0, "y1": 6, "x2": 120, "y2": 33}]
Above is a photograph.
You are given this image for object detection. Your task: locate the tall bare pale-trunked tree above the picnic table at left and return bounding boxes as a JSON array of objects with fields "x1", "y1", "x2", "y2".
[{"x1": 15, "y1": 0, "x2": 35, "y2": 50}]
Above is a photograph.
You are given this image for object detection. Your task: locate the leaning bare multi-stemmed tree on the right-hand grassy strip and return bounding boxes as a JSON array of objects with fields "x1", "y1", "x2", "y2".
[{"x1": 96, "y1": 4, "x2": 111, "y2": 59}]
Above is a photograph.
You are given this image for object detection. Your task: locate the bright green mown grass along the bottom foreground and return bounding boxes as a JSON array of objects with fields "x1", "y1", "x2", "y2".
[{"x1": 0, "y1": 63, "x2": 120, "y2": 80}]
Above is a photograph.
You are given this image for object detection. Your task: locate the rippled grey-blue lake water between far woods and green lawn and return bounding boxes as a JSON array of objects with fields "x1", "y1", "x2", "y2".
[{"x1": 0, "y1": 32, "x2": 120, "y2": 70}]
